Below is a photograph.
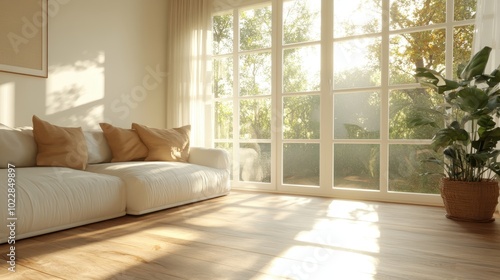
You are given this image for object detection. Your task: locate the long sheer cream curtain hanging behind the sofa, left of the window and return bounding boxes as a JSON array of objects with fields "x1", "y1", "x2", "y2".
[{"x1": 166, "y1": 0, "x2": 213, "y2": 147}]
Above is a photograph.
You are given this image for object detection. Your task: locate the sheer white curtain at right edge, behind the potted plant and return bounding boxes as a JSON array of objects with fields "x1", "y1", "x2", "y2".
[{"x1": 474, "y1": 0, "x2": 500, "y2": 212}]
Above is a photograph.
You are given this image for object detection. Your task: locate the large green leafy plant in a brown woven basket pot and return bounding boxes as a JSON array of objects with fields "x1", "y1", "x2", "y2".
[{"x1": 411, "y1": 47, "x2": 500, "y2": 222}]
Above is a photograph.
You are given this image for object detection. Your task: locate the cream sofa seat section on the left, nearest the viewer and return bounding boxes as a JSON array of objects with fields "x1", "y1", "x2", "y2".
[{"x1": 0, "y1": 167, "x2": 125, "y2": 242}]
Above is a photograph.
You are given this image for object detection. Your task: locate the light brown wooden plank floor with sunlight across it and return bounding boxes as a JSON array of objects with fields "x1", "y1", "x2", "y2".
[{"x1": 0, "y1": 191, "x2": 500, "y2": 280}]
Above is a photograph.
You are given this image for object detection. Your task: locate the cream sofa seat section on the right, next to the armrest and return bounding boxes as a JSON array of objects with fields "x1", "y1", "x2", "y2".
[{"x1": 87, "y1": 161, "x2": 230, "y2": 215}]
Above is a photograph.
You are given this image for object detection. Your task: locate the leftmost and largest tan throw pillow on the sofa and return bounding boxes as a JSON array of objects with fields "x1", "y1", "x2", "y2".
[{"x1": 33, "y1": 116, "x2": 88, "y2": 170}]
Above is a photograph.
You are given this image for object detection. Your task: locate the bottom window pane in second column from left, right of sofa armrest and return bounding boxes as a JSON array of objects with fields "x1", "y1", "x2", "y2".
[{"x1": 239, "y1": 143, "x2": 271, "y2": 183}]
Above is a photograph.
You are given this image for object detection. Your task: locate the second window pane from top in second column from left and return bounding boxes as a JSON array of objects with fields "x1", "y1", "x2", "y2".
[{"x1": 240, "y1": 52, "x2": 272, "y2": 96}]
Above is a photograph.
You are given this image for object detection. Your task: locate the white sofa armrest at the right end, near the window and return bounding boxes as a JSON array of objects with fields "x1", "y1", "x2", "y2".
[{"x1": 188, "y1": 147, "x2": 231, "y2": 170}]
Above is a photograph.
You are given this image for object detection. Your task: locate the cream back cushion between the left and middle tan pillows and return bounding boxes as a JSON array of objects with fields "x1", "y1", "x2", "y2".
[{"x1": 83, "y1": 130, "x2": 112, "y2": 164}]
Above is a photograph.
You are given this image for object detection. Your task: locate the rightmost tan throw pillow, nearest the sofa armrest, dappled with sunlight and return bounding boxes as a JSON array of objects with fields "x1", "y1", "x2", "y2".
[{"x1": 132, "y1": 123, "x2": 191, "y2": 162}]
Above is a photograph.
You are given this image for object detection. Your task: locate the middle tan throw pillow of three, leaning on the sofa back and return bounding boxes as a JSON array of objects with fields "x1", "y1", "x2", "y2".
[{"x1": 99, "y1": 123, "x2": 148, "y2": 162}]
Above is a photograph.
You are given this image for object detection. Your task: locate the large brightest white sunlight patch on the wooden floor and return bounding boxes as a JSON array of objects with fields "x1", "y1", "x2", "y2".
[{"x1": 266, "y1": 200, "x2": 381, "y2": 279}]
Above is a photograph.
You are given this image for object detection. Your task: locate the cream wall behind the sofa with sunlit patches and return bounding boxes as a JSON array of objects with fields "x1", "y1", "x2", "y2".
[{"x1": 0, "y1": 0, "x2": 167, "y2": 129}]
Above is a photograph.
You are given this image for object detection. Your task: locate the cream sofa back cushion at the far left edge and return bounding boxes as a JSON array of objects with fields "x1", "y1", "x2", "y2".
[{"x1": 0, "y1": 124, "x2": 37, "y2": 168}]
